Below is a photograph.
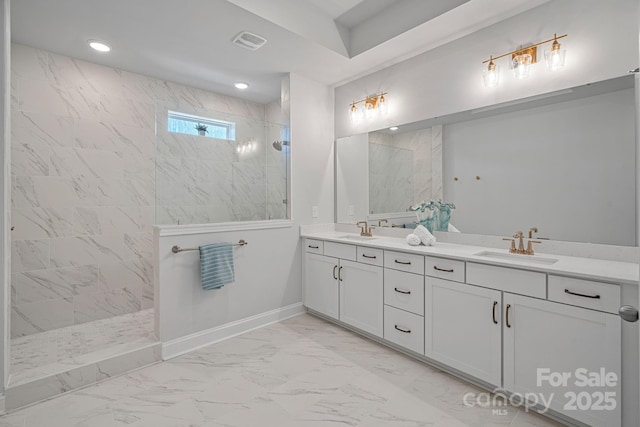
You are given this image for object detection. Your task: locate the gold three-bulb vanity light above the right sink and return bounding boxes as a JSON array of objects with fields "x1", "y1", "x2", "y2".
[{"x1": 482, "y1": 34, "x2": 567, "y2": 87}]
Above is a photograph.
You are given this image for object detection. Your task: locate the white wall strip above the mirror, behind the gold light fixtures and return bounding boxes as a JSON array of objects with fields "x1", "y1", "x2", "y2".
[{"x1": 335, "y1": 0, "x2": 638, "y2": 137}]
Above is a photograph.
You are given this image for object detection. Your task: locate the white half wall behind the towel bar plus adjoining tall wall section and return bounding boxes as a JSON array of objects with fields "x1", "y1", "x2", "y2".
[{"x1": 155, "y1": 74, "x2": 334, "y2": 347}]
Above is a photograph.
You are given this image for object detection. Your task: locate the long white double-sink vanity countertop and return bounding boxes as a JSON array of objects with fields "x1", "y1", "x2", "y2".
[{"x1": 300, "y1": 230, "x2": 640, "y2": 285}]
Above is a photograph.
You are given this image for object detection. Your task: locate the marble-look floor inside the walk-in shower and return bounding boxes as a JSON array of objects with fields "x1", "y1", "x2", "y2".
[{"x1": 9, "y1": 309, "x2": 157, "y2": 386}]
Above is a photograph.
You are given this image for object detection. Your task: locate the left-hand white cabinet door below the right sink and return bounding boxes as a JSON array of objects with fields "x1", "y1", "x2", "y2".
[{"x1": 424, "y1": 277, "x2": 502, "y2": 386}]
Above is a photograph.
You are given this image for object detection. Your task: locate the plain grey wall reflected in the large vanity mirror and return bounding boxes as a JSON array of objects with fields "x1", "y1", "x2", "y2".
[{"x1": 443, "y1": 89, "x2": 636, "y2": 246}]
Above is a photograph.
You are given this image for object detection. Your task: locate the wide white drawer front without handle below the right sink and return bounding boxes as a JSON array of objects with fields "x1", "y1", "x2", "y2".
[{"x1": 467, "y1": 262, "x2": 547, "y2": 298}]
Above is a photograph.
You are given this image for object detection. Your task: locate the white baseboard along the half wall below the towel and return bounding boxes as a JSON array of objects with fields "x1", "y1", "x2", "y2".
[{"x1": 162, "y1": 302, "x2": 307, "y2": 360}]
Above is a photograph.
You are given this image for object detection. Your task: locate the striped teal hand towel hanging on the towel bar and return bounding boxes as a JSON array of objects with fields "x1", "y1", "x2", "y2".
[{"x1": 199, "y1": 243, "x2": 236, "y2": 290}]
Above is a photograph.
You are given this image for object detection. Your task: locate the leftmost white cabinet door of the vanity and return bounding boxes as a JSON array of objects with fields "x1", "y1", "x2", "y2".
[{"x1": 304, "y1": 253, "x2": 338, "y2": 319}]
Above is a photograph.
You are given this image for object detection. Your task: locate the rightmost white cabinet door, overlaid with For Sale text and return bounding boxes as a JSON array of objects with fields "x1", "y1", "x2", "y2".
[{"x1": 504, "y1": 293, "x2": 622, "y2": 426}]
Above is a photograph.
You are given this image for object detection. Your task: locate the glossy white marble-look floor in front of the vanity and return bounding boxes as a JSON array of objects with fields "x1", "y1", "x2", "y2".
[{"x1": 0, "y1": 315, "x2": 559, "y2": 427}]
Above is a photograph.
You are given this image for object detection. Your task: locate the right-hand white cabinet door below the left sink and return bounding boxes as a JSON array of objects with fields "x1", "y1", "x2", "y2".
[{"x1": 338, "y1": 260, "x2": 384, "y2": 337}]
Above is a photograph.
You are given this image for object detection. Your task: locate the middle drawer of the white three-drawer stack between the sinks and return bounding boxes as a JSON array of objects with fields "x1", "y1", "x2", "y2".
[{"x1": 384, "y1": 268, "x2": 424, "y2": 316}]
